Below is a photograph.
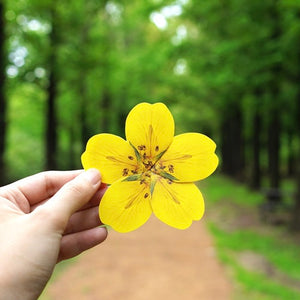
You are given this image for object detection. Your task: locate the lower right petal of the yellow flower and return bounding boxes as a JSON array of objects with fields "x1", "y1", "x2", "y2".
[{"x1": 151, "y1": 177, "x2": 204, "y2": 229}]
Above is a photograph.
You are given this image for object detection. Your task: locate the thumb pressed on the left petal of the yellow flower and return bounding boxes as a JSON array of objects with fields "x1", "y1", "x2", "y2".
[{"x1": 47, "y1": 169, "x2": 101, "y2": 223}]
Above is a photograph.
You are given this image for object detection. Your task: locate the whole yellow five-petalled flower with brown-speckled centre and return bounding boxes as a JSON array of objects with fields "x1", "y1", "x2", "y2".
[{"x1": 81, "y1": 103, "x2": 218, "y2": 232}]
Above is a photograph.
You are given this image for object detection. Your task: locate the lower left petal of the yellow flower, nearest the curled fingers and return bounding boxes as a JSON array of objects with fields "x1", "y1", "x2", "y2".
[{"x1": 99, "y1": 181, "x2": 152, "y2": 232}]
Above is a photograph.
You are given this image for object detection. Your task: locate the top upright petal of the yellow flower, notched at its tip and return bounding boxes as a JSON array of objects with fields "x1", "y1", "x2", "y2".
[{"x1": 125, "y1": 103, "x2": 174, "y2": 158}]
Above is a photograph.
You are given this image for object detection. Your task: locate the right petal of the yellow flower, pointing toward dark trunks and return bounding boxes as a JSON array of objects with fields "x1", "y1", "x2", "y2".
[{"x1": 159, "y1": 133, "x2": 219, "y2": 182}]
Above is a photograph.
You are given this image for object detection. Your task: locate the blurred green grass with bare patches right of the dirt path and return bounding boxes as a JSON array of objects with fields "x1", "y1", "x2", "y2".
[{"x1": 200, "y1": 176, "x2": 300, "y2": 300}]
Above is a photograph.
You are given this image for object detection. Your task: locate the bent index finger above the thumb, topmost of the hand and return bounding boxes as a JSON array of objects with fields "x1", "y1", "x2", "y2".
[{"x1": 10, "y1": 170, "x2": 83, "y2": 205}]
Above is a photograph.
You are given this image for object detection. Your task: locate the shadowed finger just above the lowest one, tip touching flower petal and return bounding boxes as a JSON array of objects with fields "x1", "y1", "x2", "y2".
[{"x1": 64, "y1": 206, "x2": 102, "y2": 235}]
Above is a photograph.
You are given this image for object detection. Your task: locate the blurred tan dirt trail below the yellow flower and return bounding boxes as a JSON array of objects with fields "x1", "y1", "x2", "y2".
[{"x1": 46, "y1": 217, "x2": 232, "y2": 300}]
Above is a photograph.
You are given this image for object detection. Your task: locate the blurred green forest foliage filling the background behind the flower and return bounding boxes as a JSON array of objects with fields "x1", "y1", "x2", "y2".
[{"x1": 1, "y1": 0, "x2": 300, "y2": 209}]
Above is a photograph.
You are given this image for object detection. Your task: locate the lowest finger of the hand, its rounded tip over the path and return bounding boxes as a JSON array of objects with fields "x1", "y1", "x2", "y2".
[{"x1": 57, "y1": 227, "x2": 107, "y2": 262}]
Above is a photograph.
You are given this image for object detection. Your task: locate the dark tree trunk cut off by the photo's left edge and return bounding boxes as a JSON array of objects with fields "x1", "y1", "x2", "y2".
[{"x1": 0, "y1": 1, "x2": 6, "y2": 185}]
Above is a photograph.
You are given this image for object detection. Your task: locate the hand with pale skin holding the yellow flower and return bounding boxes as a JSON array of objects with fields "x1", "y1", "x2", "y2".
[{"x1": 0, "y1": 169, "x2": 107, "y2": 300}]
